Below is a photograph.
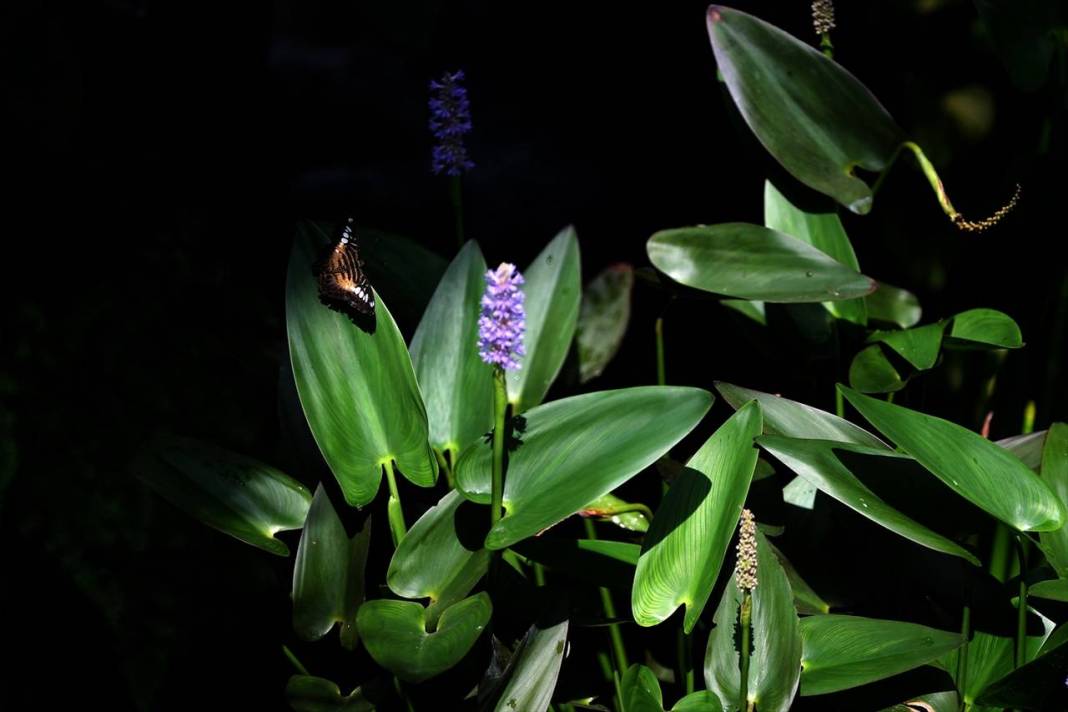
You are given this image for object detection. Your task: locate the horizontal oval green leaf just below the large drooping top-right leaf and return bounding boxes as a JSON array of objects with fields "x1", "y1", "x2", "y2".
[{"x1": 645, "y1": 222, "x2": 876, "y2": 302}]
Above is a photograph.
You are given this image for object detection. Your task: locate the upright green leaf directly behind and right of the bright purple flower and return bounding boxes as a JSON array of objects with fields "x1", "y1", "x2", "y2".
[{"x1": 504, "y1": 226, "x2": 582, "y2": 413}]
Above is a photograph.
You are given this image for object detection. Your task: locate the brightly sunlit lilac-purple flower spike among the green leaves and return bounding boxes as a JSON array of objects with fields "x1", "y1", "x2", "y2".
[{"x1": 478, "y1": 263, "x2": 525, "y2": 370}]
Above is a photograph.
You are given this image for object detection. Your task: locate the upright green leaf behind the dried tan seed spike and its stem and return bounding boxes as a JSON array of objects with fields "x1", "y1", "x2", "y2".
[{"x1": 705, "y1": 532, "x2": 801, "y2": 712}]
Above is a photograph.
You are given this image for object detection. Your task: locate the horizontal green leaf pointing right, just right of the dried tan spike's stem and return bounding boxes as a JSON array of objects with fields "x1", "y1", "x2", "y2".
[{"x1": 801, "y1": 614, "x2": 963, "y2": 696}]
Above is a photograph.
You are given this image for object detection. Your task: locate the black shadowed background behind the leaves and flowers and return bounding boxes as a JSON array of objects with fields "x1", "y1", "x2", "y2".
[{"x1": 0, "y1": 0, "x2": 1068, "y2": 710}]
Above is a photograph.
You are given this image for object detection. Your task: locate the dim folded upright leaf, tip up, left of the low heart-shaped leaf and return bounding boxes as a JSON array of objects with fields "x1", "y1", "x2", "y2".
[{"x1": 293, "y1": 485, "x2": 371, "y2": 650}]
